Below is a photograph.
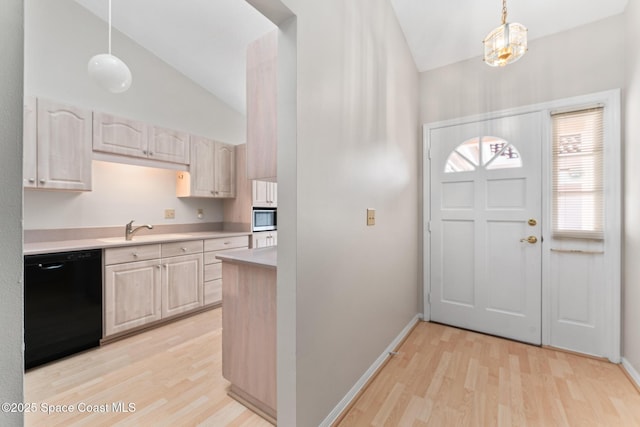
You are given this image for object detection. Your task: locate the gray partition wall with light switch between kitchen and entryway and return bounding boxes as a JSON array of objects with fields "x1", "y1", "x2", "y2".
[{"x1": 278, "y1": 0, "x2": 421, "y2": 427}]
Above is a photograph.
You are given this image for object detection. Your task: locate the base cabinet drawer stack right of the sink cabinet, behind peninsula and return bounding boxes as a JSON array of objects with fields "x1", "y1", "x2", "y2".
[{"x1": 204, "y1": 236, "x2": 249, "y2": 305}]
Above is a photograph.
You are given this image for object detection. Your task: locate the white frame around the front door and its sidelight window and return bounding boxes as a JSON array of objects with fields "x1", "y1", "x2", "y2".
[{"x1": 422, "y1": 89, "x2": 622, "y2": 363}]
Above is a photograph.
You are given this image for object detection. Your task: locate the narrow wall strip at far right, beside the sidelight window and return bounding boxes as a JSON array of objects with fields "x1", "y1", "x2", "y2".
[{"x1": 622, "y1": 0, "x2": 640, "y2": 372}]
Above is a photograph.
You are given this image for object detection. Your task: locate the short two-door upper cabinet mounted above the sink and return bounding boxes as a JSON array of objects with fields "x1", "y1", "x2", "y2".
[{"x1": 93, "y1": 112, "x2": 189, "y2": 164}]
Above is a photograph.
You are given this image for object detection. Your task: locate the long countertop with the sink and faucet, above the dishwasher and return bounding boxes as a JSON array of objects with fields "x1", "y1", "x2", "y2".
[{"x1": 24, "y1": 231, "x2": 251, "y2": 255}]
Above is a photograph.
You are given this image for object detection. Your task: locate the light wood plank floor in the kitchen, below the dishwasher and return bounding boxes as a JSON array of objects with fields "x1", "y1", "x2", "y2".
[{"x1": 25, "y1": 309, "x2": 271, "y2": 427}]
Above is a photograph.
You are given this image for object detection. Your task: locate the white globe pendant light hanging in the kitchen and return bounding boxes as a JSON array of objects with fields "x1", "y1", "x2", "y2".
[{"x1": 87, "y1": 0, "x2": 132, "y2": 93}]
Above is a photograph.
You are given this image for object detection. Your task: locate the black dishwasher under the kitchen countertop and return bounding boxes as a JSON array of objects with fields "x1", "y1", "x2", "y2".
[{"x1": 24, "y1": 249, "x2": 102, "y2": 369}]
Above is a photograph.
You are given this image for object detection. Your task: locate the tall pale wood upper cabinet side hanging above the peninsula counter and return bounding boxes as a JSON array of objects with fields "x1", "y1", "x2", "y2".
[{"x1": 247, "y1": 30, "x2": 278, "y2": 180}]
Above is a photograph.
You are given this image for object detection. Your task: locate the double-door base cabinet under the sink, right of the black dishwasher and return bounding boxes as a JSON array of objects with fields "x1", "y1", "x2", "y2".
[{"x1": 104, "y1": 240, "x2": 204, "y2": 336}]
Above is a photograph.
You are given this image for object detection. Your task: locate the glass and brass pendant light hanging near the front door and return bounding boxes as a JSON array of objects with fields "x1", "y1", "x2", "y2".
[{"x1": 482, "y1": 0, "x2": 527, "y2": 67}]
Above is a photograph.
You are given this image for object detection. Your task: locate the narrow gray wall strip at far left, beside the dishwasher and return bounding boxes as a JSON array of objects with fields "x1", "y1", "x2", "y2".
[{"x1": 0, "y1": 0, "x2": 24, "y2": 427}]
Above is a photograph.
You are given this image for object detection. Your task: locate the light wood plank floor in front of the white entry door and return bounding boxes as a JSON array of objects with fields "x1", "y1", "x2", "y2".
[{"x1": 339, "y1": 322, "x2": 640, "y2": 427}]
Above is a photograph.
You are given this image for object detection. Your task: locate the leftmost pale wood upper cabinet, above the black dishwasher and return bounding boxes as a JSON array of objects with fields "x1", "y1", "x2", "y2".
[{"x1": 23, "y1": 98, "x2": 92, "y2": 191}]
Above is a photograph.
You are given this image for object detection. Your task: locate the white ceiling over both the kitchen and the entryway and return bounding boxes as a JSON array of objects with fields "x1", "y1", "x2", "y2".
[{"x1": 75, "y1": 0, "x2": 628, "y2": 113}]
